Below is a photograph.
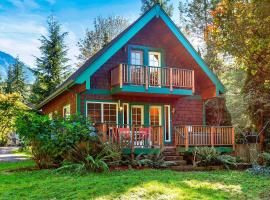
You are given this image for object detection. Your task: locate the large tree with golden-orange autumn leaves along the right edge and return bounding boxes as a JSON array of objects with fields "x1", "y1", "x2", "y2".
[{"x1": 211, "y1": 0, "x2": 270, "y2": 150}]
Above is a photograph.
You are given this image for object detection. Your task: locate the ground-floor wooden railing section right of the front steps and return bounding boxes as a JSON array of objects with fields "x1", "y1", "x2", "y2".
[{"x1": 174, "y1": 126, "x2": 234, "y2": 149}]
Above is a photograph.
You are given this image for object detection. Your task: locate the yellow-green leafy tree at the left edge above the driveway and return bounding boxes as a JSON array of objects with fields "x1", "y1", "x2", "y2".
[{"x1": 0, "y1": 93, "x2": 27, "y2": 145}]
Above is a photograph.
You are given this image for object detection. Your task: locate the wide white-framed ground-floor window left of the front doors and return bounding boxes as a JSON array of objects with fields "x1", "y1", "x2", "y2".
[{"x1": 87, "y1": 103, "x2": 117, "y2": 124}]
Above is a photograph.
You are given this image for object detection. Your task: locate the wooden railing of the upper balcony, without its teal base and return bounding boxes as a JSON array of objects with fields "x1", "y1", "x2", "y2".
[{"x1": 111, "y1": 64, "x2": 195, "y2": 92}]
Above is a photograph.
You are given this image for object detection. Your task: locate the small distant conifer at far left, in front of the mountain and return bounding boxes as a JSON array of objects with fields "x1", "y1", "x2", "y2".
[{"x1": 5, "y1": 57, "x2": 26, "y2": 98}]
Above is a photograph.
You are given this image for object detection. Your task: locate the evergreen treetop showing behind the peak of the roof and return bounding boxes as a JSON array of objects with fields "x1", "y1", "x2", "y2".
[{"x1": 141, "y1": 0, "x2": 173, "y2": 17}]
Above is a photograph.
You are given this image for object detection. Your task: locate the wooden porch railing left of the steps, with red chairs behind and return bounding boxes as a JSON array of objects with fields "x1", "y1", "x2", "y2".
[{"x1": 94, "y1": 123, "x2": 164, "y2": 149}]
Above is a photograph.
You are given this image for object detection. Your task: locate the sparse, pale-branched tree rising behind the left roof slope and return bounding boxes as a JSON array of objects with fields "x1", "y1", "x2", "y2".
[{"x1": 78, "y1": 16, "x2": 129, "y2": 65}]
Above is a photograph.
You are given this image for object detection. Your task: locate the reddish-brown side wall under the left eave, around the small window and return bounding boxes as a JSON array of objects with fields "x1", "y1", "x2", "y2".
[{"x1": 41, "y1": 84, "x2": 85, "y2": 116}]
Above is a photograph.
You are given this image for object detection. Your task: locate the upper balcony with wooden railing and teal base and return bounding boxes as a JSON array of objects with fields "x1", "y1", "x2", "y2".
[{"x1": 110, "y1": 64, "x2": 195, "y2": 95}]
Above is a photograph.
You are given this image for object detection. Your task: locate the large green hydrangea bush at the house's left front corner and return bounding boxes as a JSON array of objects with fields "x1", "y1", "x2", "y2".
[{"x1": 16, "y1": 112, "x2": 98, "y2": 168}]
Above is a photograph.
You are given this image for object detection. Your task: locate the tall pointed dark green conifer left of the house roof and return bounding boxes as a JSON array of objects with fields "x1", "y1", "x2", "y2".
[{"x1": 31, "y1": 16, "x2": 70, "y2": 103}]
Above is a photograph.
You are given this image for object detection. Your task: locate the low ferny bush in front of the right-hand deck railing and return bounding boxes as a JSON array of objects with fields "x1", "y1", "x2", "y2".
[{"x1": 193, "y1": 147, "x2": 237, "y2": 168}]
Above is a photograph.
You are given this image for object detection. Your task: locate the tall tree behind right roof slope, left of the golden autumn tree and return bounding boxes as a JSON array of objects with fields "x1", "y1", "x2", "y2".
[{"x1": 178, "y1": 0, "x2": 224, "y2": 75}]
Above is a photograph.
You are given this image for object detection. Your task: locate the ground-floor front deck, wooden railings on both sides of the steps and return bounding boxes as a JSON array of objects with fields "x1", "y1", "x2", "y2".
[{"x1": 95, "y1": 123, "x2": 235, "y2": 154}]
